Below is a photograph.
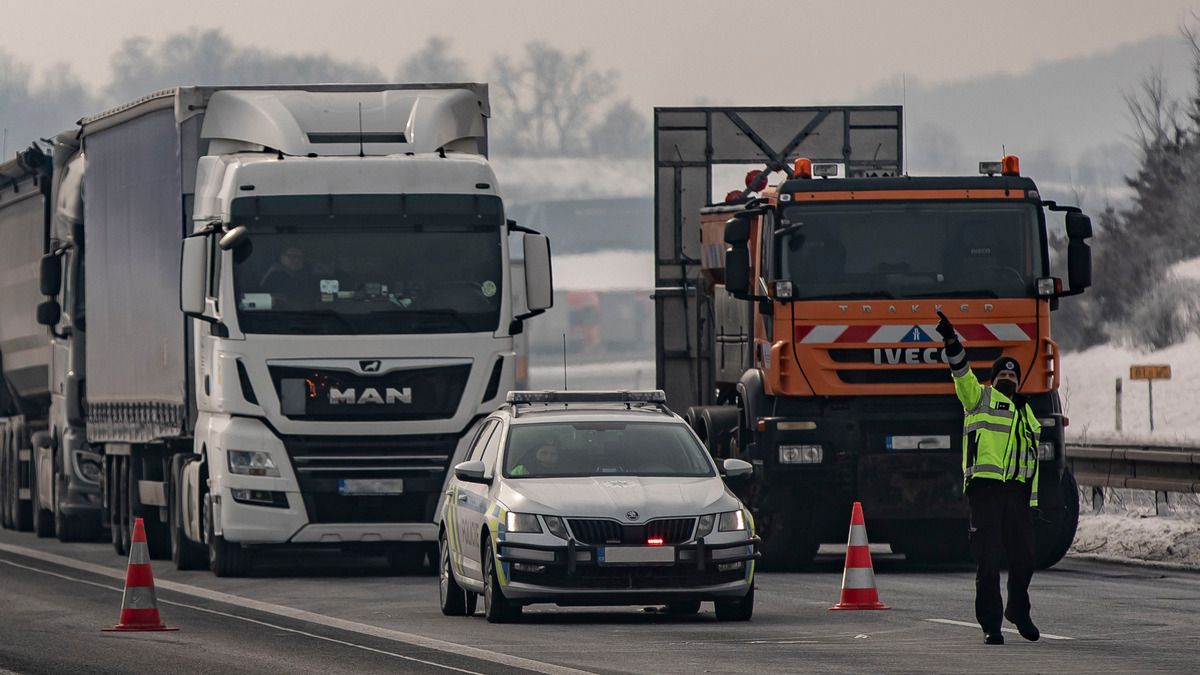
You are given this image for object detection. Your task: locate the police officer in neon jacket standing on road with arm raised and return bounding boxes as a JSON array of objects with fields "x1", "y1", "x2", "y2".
[{"x1": 937, "y1": 312, "x2": 1042, "y2": 645}]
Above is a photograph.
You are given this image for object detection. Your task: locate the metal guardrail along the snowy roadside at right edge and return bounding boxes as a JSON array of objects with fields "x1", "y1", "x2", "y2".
[{"x1": 1066, "y1": 443, "x2": 1200, "y2": 492}]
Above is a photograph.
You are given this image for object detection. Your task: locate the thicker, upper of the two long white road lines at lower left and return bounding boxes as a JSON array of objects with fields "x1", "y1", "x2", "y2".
[{"x1": 0, "y1": 543, "x2": 593, "y2": 675}]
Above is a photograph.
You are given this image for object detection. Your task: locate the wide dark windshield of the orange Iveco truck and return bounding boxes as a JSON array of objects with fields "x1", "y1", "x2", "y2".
[{"x1": 776, "y1": 202, "x2": 1046, "y2": 299}]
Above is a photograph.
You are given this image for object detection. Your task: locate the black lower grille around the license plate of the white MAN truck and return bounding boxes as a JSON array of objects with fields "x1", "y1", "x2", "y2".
[{"x1": 283, "y1": 434, "x2": 458, "y2": 524}]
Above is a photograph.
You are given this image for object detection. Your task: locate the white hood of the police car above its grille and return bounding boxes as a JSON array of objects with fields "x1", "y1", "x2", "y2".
[{"x1": 500, "y1": 476, "x2": 742, "y2": 524}]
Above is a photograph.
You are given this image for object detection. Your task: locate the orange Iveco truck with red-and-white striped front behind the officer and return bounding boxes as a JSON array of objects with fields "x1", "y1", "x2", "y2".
[{"x1": 659, "y1": 103, "x2": 1091, "y2": 569}]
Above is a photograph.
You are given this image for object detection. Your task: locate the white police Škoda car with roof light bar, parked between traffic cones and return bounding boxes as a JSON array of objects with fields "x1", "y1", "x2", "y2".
[{"x1": 439, "y1": 390, "x2": 760, "y2": 622}]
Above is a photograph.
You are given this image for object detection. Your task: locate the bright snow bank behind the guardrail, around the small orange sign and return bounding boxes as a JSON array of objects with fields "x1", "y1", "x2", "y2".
[{"x1": 1060, "y1": 331, "x2": 1200, "y2": 444}]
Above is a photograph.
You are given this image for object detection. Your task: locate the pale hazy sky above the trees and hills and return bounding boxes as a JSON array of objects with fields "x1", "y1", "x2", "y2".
[{"x1": 7, "y1": 0, "x2": 1200, "y2": 108}]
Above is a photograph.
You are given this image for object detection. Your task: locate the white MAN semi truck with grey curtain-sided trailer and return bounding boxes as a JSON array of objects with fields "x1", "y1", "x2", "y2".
[{"x1": 0, "y1": 84, "x2": 552, "y2": 575}]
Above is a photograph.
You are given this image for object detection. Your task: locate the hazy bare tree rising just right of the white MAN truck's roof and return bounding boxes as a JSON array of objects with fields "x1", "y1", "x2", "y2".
[{"x1": 492, "y1": 42, "x2": 617, "y2": 155}]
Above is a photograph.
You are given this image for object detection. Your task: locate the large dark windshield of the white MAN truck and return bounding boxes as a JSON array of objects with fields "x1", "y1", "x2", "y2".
[{"x1": 232, "y1": 195, "x2": 506, "y2": 335}]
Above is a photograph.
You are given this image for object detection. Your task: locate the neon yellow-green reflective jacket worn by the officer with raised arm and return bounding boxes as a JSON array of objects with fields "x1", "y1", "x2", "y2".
[{"x1": 953, "y1": 363, "x2": 1042, "y2": 507}]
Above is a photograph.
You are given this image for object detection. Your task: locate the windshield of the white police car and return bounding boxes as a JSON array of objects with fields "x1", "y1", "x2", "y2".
[{"x1": 504, "y1": 422, "x2": 714, "y2": 478}]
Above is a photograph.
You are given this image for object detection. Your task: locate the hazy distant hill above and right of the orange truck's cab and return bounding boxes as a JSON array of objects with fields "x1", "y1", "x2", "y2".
[{"x1": 860, "y1": 35, "x2": 1194, "y2": 204}]
